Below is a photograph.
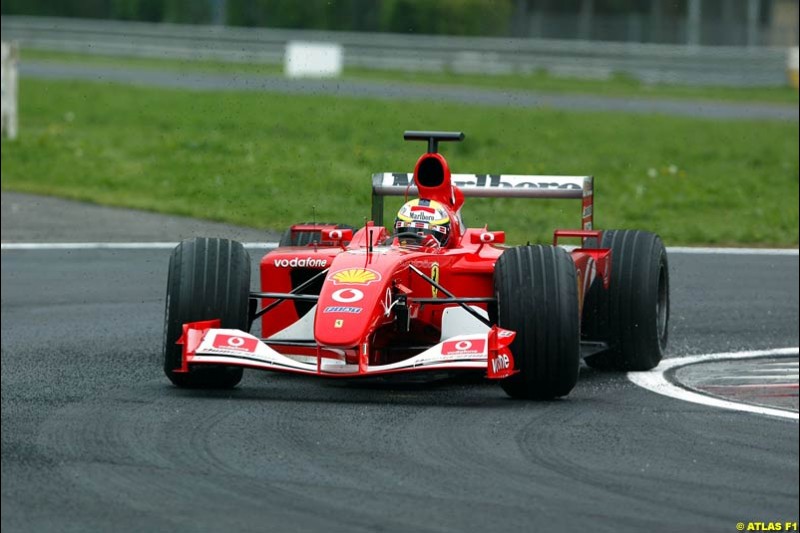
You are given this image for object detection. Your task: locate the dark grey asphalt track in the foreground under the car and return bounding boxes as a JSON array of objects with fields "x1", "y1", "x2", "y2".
[{"x1": 0, "y1": 192, "x2": 798, "y2": 532}]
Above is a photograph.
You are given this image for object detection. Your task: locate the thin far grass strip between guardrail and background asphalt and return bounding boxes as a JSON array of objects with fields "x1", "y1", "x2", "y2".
[{"x1": 22, "y1": 49, "x2": 799, "y2": 104}]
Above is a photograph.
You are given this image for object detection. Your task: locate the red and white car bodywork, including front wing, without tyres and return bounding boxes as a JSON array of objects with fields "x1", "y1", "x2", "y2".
[{"x1": 179, "y1": 145, "x2": 610, "y2": 379}]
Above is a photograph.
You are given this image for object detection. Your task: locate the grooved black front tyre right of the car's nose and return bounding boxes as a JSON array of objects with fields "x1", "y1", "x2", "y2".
[{"x1": 494, "y1": 246, "x2": 580, "y2": 399}]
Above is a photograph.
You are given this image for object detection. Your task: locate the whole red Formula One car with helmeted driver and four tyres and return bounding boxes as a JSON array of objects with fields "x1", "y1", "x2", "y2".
[{"x1": 164, "y1": 132, "x2": 669, "y2": 399}]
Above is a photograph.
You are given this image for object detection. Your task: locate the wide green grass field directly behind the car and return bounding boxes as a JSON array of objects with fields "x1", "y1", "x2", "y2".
[{"x1": 2, "y1": 79, "x2": 798, "y2": 246}]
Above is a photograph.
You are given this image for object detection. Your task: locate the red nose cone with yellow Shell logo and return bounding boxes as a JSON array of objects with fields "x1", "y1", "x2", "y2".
[{"x1": 314, "y1": 252, "x2": 400, "y2": 348}]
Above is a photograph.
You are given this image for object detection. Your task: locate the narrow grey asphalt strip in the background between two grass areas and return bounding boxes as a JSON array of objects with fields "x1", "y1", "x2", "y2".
[{"x1": 20, "y1": 61, "x2": 798, "y2": 122}]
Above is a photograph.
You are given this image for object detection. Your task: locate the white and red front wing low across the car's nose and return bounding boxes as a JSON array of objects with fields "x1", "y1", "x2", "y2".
[{"x1": 176, "y1": 320, "x2": 516, "y2": 379}]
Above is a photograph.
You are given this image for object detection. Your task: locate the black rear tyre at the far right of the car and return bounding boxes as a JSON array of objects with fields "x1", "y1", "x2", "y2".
[{"x1": 583, "y1": 230, "x2": 669, "y2": 371}]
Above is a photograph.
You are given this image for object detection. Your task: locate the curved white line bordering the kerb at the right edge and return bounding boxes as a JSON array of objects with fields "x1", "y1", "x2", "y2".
[{"x1": 628, "y1": 347, "x2": 800, "y2": 420}]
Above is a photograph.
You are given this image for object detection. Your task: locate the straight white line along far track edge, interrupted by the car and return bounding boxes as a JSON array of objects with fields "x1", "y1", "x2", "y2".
[{"x1": 0, "y1": 242, "x2": 798, "y2": 256}]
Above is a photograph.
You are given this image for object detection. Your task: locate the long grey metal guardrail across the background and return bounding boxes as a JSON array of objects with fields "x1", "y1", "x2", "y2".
[{"x1": 2, "y1": 16, "x2": 787, "y2": 87}]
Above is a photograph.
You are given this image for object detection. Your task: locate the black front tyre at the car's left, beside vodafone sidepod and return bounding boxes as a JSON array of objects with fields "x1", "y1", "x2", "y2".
[{"x1": 164, "y1": 238, "x2": 250, "y2": 389}]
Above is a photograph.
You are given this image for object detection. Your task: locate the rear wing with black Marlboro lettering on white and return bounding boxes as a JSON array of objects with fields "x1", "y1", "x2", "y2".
[{"x1": 372, "y1": 173, "x2": 594, "y2": 230}]
